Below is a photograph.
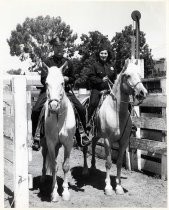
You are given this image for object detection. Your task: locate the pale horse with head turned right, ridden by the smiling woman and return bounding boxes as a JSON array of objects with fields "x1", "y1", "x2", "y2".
[{"x1": 83, "y1": 60, "x2": 147, "y2": 195}]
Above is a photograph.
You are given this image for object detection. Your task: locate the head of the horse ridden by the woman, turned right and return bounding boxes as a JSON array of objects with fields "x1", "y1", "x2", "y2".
[{"x1": 122, "y1": 59, "x2": 148, "y2": 102}]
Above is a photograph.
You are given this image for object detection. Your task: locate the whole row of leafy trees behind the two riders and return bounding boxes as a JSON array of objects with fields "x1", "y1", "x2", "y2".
[{"x1": 7, "y1": 16, "x2": 154, "y2": 84}]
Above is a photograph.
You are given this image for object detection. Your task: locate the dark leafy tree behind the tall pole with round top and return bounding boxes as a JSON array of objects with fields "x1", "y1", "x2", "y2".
[{"x1": 111, "y1": 25, "x2": 154, "y2": 77}]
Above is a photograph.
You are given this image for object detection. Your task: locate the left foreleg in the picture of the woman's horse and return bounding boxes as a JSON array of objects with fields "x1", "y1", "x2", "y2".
[{"x1": 104, "y1": 139, "x2": 113, "y2": 195}]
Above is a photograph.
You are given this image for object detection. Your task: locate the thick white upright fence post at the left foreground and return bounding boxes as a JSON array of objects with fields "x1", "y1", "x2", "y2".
[{"x1": 12, "y1": 76, "x2": 29, "y2": 208}]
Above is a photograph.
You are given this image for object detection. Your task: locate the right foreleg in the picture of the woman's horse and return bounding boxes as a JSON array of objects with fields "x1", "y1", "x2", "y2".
[{"x1": 116, "y1": 145, "x2": 126, "y2": 195}]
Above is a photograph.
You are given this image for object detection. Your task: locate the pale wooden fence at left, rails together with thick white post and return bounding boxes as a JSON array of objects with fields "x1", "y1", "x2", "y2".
[{"x1": 3, "y1": 76, "x2": 32, "y2": 208}]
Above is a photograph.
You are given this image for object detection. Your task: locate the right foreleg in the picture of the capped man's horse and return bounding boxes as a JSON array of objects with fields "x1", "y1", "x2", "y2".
[{"x1": 62, "y1": 149, "x2": 70, "y2": 201}]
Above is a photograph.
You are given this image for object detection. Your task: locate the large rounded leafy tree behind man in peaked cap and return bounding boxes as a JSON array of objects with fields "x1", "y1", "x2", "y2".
[{"x1": 7, "y1": 16, "x2": 77, "y2": 70}]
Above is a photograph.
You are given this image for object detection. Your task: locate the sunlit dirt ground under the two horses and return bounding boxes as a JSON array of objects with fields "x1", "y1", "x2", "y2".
[{"x1": 4, "y1": 137, "x2": 167, "y2": 208}]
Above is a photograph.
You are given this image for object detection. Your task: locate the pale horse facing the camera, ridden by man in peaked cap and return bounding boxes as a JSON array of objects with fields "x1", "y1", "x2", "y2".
[{"x1": 41, "y1": 63, "x2": 76, "y2": 202}]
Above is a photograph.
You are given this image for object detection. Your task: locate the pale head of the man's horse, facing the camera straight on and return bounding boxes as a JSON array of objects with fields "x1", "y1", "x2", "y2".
[{"x1": 46, "y1": 61, "x2": 67, "y2": 113}]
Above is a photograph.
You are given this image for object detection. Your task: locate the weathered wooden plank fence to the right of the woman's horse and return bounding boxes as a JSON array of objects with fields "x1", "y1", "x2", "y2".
[{"x1": 129, "y1": 78, "x2": 167, "y2": 179}]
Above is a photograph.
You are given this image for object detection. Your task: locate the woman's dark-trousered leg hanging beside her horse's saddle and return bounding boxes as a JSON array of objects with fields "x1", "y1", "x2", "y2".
[{"x1": 87, "y1": 89, "x2": 100, "y2": 122}]
